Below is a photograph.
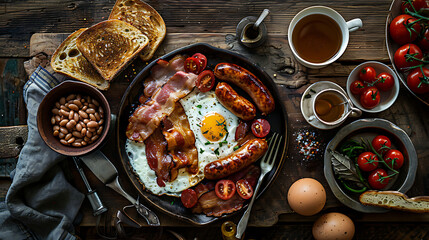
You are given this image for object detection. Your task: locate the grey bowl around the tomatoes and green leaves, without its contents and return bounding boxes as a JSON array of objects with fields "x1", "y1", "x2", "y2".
[{"x1": 324, "y1": 118, "x2": 417, "y2": 213}]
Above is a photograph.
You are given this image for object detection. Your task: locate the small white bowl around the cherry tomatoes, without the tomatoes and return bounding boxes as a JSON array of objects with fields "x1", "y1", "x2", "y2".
[{"x1": 346, "y1": 61, "x2": 400, "y2": 113}]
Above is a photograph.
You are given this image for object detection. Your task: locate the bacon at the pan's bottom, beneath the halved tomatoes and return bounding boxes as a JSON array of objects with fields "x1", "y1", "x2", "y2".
[{"x1": 192, "y1": 165, "x2": 261, "y2": 217}]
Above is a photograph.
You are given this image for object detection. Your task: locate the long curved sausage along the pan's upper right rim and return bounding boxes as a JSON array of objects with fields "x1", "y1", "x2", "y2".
[{"x1": 214, "y1": 63, "x2": 275, "y2": 115}]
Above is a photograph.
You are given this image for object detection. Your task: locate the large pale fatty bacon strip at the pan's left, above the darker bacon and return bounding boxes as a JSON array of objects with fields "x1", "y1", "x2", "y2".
[{"x1": 126, "y1": 71, "x2": 197, "y2": 142}]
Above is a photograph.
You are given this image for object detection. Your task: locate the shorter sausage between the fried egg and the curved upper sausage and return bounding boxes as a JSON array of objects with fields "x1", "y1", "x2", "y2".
[{"x1": 215, "y1": 82, "x2": 256, "y2": 121}]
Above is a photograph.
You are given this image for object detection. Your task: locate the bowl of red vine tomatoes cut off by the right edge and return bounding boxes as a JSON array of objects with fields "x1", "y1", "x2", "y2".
[{"x1": 385, "y1": 0, "x2": 429, "y2": 106}]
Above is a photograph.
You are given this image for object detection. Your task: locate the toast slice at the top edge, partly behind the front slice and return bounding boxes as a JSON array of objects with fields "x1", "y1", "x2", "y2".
[{"x1": 109, "y1": 0, "x2": 166, "y2": 61}]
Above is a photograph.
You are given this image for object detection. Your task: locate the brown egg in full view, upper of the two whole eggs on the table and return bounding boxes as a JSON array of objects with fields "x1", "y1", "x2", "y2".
[{"x1": 287, "y1": 178, "x2": 326, "y2": 216}]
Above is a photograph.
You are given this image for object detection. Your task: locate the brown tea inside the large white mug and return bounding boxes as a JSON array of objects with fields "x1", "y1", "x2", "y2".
[{"x1": 292, "y1": 14, "x2": 343, "y2": 63}]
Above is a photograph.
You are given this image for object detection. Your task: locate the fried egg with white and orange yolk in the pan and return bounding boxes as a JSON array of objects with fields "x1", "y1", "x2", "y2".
[{"x1": 125, "y1": 88, "x2": 239, "y2": 196}]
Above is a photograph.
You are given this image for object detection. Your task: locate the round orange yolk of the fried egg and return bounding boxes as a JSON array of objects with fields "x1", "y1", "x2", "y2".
[{"x1": 201, "y1": 113, "x2": 227, "y2": 142}]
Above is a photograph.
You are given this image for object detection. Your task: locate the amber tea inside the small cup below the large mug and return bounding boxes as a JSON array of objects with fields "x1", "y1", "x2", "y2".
[{"x1": 314, "y1": 92, "x2": 344, "y2": 122}]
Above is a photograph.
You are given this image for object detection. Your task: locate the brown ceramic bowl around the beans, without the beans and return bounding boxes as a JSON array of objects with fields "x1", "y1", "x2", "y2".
[{"x1": 37, "y1": 80, "x2": 110, "y2": 156}]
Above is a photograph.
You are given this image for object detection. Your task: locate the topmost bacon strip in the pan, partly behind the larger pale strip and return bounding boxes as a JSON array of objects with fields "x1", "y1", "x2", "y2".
[{"x1": 143, "y1": 55, "x2": 185, "y2": 98}]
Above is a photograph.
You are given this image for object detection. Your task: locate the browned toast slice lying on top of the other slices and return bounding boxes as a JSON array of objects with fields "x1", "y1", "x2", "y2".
[{"x1": 76, "y1": 19, "x2": 149, "y2": 82}]
